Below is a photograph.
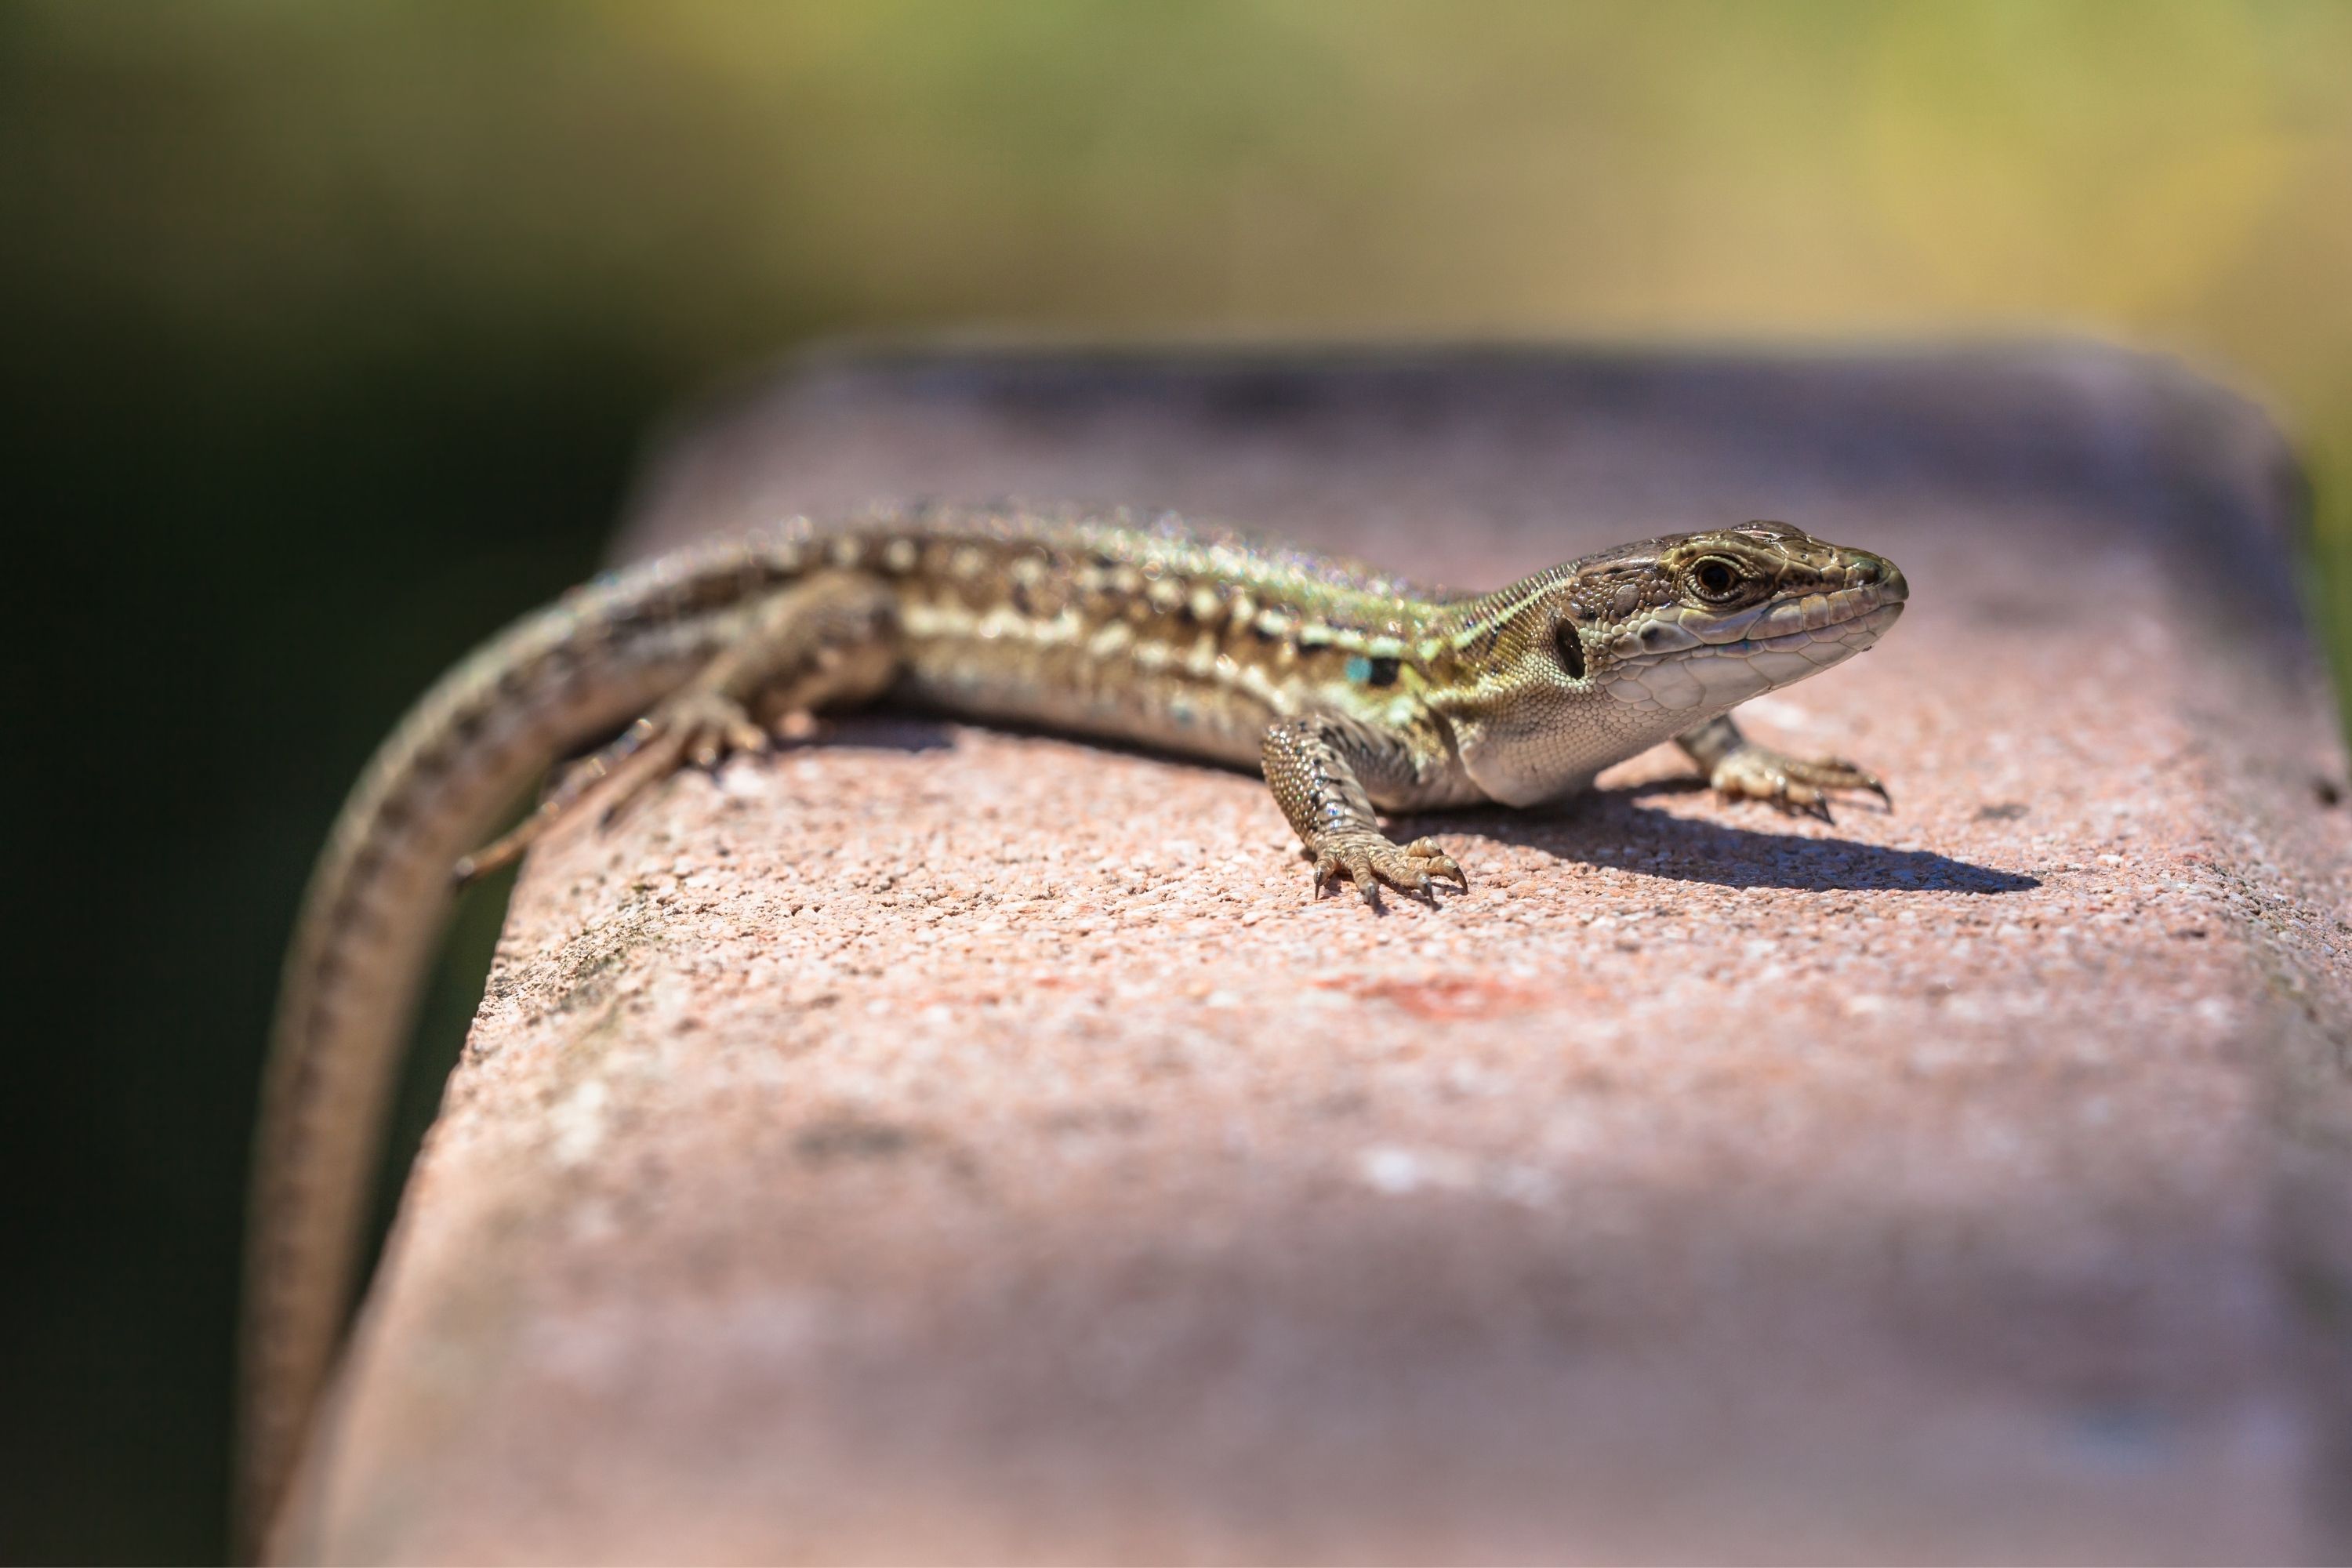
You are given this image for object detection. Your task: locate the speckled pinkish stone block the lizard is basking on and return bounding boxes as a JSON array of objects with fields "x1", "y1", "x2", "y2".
[{"x1": 289, "y1": 348, "x2": 2352, "y2": 1561}]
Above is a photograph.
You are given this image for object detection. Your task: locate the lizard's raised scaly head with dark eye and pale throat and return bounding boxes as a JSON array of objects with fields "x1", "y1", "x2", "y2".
[{"x1": 1432, "y1": 522, "x2": 1910, "y2": 806}]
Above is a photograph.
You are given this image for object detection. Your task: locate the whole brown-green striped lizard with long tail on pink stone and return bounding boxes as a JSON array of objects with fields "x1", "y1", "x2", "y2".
[{"x1": 238, "y1": 508, "x2": 1907, "y2": 1547}]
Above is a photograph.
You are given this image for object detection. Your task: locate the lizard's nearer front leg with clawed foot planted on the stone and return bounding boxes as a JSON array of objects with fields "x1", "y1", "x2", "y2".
[{"x1": 1261, "y1": 715, "x2": 1470, "y2": 902}]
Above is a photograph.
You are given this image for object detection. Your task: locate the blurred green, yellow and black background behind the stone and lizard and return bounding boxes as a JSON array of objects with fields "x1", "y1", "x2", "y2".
[{"x1": 0, "y1": 0, "x2": 2352, "y2": 1561}]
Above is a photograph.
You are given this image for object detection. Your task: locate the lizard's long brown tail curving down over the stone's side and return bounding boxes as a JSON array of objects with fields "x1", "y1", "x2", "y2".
[{"x1": 235, "y1": 550, "x2": 774, "y2": 1556}]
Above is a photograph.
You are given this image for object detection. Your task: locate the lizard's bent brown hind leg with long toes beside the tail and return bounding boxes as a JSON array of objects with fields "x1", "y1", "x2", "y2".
[{"x1": 454, "y1": 572, "x2": 898, "y2": 886}]
